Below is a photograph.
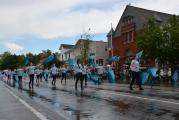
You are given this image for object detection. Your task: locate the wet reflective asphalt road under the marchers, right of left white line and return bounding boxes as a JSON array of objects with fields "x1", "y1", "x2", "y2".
[{"x1": 1, "y1": 79, "x2": 179, "y2": 120}]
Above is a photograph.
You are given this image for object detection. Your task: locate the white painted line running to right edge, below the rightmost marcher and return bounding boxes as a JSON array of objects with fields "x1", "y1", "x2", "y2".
[{"x1": 101, "y1": 91, "x2": 179, "y2": 105}]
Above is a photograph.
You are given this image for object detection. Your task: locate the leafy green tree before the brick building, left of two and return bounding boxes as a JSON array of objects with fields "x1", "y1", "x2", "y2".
[{"x1": 137, "y1": 17, "x2": 162, "y2": 59}]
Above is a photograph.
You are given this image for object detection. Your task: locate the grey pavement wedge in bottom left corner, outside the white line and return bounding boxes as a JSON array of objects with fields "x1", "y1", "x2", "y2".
[{"x1": 0, "y1": 81, "x2": 41, "y2": 120}]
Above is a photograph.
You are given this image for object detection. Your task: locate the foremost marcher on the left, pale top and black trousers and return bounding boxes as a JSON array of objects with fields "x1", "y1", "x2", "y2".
[{"x1": 28, "y1": 63, "x2": 35, "y2": 89}]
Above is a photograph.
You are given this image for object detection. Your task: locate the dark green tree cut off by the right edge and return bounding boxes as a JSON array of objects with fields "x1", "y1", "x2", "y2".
[{"x1": 163, "y1": 15, "x2": 179, "y2": 65}]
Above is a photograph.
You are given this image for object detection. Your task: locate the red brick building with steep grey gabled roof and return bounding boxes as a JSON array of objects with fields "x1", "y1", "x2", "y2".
[{"x1": 107, "y1": 5, "x2": 172, "y2": 64}]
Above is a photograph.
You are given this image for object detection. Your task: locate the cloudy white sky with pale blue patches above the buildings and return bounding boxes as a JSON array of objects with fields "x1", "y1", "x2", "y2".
[{"x1": 0, "y1": 0, "x2": 179, "y2": 54}]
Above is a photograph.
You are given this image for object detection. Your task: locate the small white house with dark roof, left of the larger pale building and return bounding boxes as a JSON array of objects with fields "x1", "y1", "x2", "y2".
[{"x1": 59, "y1": 44, "x2": 74, "y2": 61}]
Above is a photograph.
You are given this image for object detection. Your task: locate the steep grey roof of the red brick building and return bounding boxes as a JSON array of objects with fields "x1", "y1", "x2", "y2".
[{"x1": 114, "y1": 5, "x2": 172, "y2": 37}]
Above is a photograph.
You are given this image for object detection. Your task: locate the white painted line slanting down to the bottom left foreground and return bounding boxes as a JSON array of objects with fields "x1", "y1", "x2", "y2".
[{"x1": 7, "y1": 89, "x2": 48, "y2": 120}]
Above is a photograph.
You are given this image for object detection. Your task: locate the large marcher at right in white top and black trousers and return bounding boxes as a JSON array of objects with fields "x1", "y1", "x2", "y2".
[{"x1": 129, "y1": 55, "x2": 143, "y2": 90}]
